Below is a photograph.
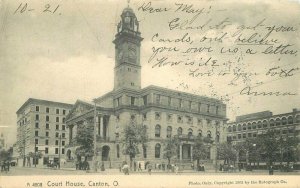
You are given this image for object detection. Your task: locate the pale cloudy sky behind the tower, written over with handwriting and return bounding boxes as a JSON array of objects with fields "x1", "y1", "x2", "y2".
[{"x1": 0, "y1": 0, "x2": 300, "y2": 144}]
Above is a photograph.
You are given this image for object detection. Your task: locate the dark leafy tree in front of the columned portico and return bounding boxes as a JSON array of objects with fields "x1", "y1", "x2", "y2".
[{"x1": 75, "y1": 124, "x2": 94, "y2": 157}]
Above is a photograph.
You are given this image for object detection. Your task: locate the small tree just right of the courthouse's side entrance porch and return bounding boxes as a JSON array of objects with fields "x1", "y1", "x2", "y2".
[{"x1": 193, "y1": 136, "x2": 210, "y2": 166}]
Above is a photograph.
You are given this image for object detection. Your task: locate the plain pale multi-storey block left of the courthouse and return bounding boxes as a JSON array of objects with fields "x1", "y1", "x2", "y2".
[{"x1": 14, "y1": 98, "x2": 72, "y2": 166}]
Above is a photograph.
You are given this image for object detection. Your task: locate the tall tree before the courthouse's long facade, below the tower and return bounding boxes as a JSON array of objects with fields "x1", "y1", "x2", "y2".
[{"x1": 121, "y1": 123, "x2": 148, "y2": 167}]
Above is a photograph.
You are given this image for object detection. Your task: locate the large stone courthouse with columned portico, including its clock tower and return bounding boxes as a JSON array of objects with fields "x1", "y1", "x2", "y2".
[{"x1": 66, "y1": 7, "x2": 227, "y2": 167}]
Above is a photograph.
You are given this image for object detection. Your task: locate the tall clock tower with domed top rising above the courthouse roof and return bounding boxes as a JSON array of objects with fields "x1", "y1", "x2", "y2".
[{"x1": 113, "y1": 6, "x2": 143, "y2": 90}]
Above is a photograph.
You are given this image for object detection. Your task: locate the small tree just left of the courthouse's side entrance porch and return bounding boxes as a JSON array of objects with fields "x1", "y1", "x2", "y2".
[{"x1": 164, "y1": 137, "x2": 180, "y2": 165}]
